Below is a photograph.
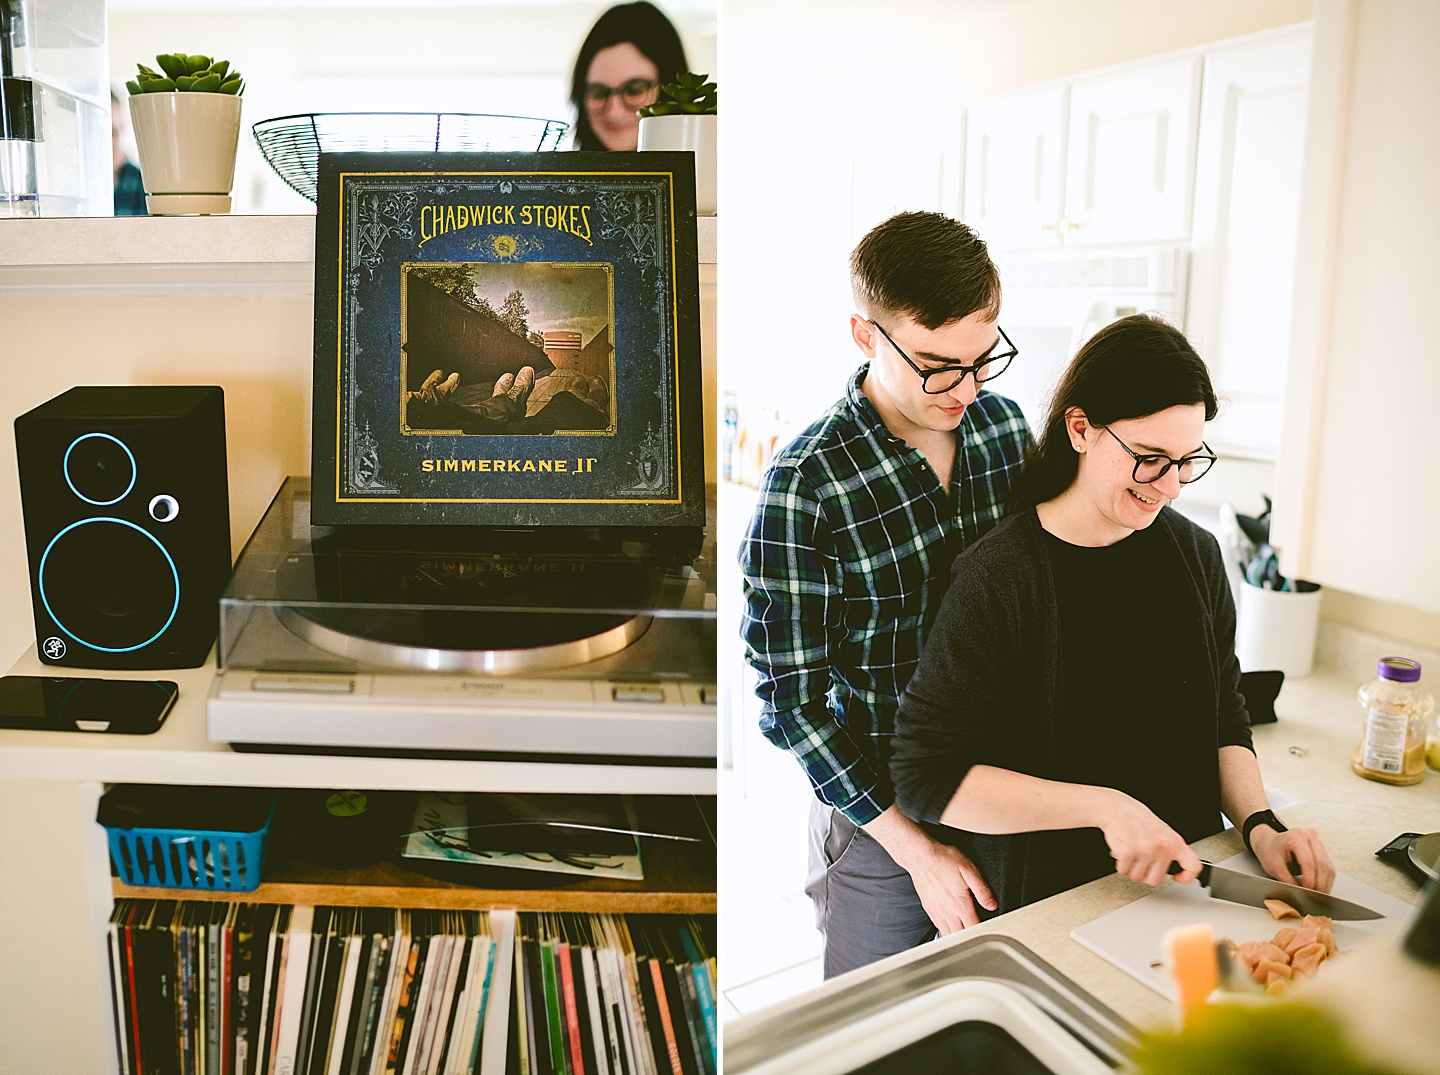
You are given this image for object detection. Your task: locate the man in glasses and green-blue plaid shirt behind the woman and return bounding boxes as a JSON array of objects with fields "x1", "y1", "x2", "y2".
[{"x1": 740, "y1": 213, "x2": 1030, "y2": 977}]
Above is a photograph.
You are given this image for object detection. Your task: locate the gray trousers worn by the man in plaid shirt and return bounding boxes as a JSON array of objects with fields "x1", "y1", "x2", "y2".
[{"x1": 805, "y1": 799, "x2": 936, "y2": 979}]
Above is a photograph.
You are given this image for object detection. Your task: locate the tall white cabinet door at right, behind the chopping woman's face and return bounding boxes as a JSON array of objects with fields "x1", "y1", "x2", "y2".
[{"x1": 1185, "y1": 30, "x2": 1310, "y2": 459}]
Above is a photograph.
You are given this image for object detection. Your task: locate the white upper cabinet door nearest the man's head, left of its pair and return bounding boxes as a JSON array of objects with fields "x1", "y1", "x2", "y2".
[{"x1": 965, "y1": 88, "x2": 1066, "y2": 250}]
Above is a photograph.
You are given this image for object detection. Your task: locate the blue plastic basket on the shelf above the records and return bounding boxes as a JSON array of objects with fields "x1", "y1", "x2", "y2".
[{"x1": 105, "y1": 803, "x2": 275, "y2": 892}]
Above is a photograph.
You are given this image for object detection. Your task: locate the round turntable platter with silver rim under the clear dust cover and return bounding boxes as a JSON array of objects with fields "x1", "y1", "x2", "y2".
[{"x1": 278, "y1": 606, "x2": 651, "y2": 675}]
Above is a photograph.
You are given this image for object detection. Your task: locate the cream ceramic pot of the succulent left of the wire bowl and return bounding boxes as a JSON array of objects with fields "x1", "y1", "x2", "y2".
[{"x1": 130, "y1": 92, "x2": 240, "y2": 216}]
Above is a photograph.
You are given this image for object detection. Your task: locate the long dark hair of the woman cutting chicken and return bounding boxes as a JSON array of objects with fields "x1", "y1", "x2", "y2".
[{"x1": 1009, "y1": 314, "x2": 1218, "y2": 511}]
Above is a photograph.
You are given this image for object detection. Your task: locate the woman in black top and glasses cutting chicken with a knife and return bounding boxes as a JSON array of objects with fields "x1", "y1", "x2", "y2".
[{"x1": 890, "y1": 315, "x2": 1335, "y2": 917}]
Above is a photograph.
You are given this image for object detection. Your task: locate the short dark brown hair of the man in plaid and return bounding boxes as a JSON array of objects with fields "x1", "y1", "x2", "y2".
[{"x1": 850, "y1": 213, "x2": 1001, "y2": 330}]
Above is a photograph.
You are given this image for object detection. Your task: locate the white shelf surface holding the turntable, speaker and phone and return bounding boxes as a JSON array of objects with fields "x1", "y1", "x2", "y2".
[{"x1": 0, "y1": 646, "x2": 716, "y2": 794}]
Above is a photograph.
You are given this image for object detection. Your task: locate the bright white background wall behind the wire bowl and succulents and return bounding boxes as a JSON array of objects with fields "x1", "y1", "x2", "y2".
[{"x1": 109, "y1": 0, "x2": 717, "y2": 213}]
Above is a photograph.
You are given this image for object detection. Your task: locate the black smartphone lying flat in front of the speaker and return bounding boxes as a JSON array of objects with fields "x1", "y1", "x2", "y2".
[{"x1": 0, "y1": 675, "x2": 180, "y2": 735}]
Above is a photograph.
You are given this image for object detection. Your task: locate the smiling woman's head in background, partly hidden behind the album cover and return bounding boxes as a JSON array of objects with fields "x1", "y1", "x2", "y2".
[{"x1": 570, "y1": 0, "x2": 688, "y2": 151}]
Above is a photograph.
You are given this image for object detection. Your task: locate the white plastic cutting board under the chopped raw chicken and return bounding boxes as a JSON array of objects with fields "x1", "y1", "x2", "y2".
[{"x1": 1070, "y1": 852, "x2": 1411, "y2": 1000}]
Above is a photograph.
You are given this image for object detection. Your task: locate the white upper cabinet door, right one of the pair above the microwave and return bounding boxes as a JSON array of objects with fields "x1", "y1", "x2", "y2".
[{"x1": 1064, "y1": 58, "x2": 1200, "y2": 245}]
